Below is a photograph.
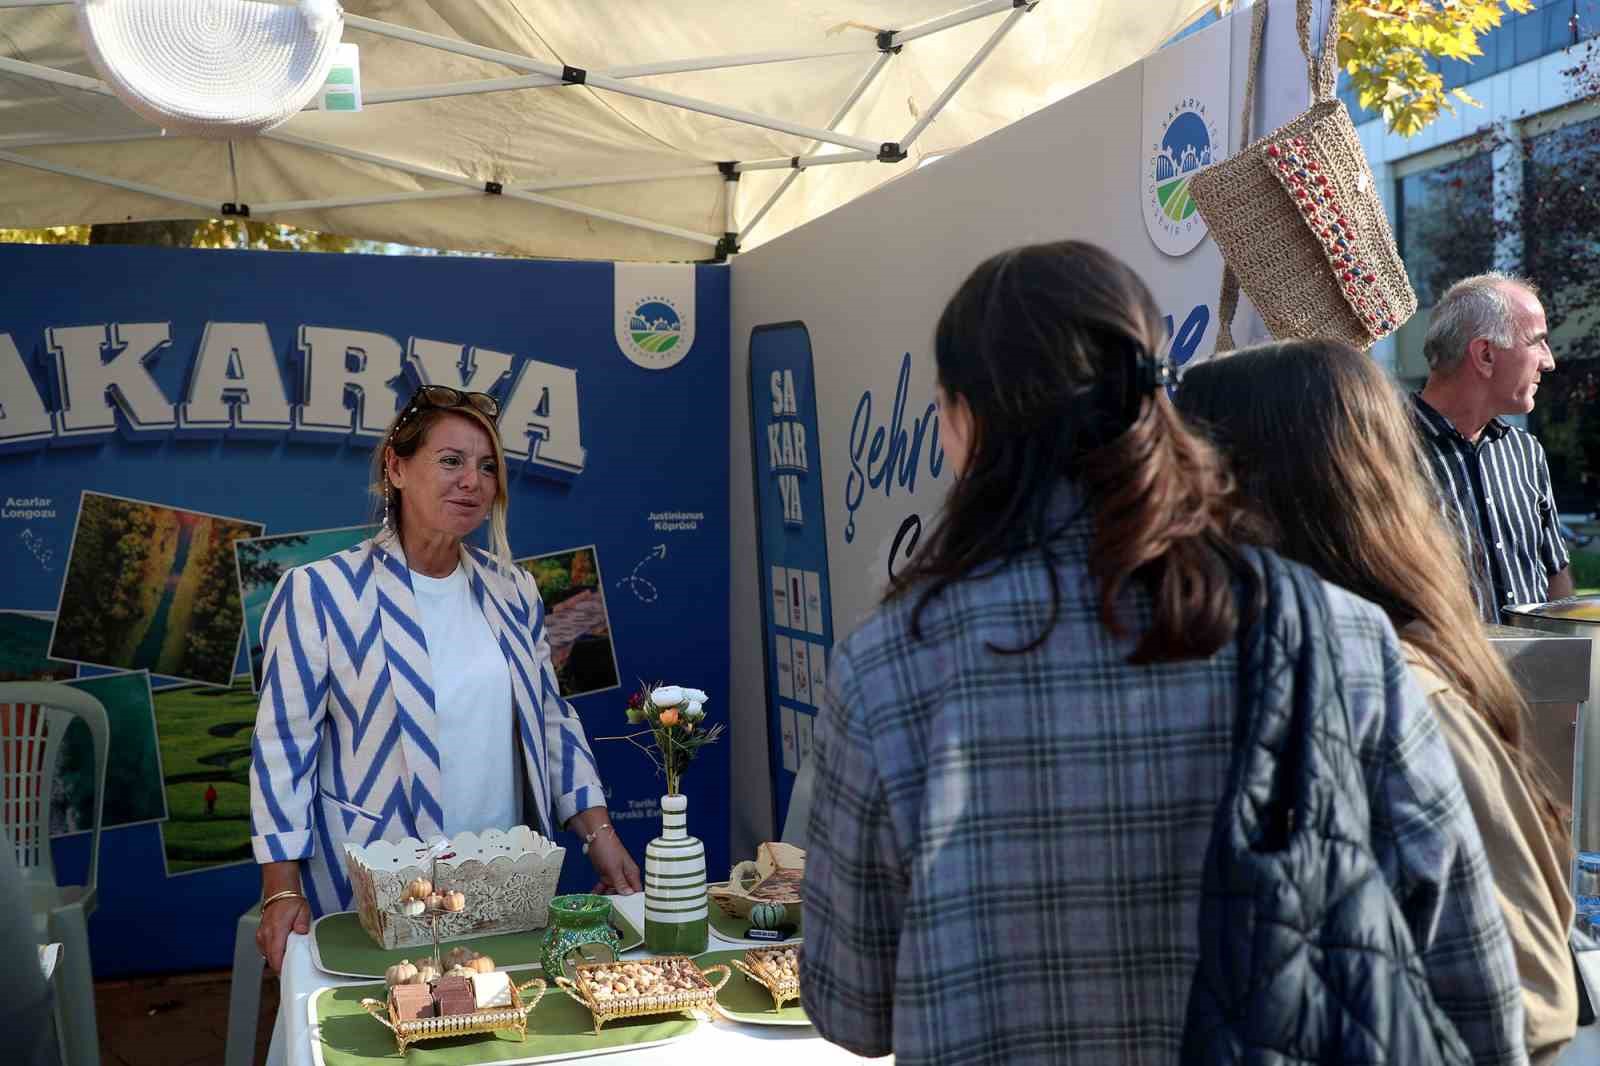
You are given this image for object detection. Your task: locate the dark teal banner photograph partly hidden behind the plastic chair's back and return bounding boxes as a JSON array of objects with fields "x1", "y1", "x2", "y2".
[{"x1": 50, "y1": 671, "x2": 166, "y2": 837}]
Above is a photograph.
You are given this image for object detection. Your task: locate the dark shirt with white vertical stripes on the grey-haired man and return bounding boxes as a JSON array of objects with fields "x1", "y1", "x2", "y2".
[{"x1": 1411, "y1": 394, "x2": 1568, "y2": 623}]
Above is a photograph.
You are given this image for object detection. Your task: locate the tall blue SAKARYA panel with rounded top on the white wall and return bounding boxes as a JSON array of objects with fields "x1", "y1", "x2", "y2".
[{"x1": 750, "y1": 322, "x2": 834, "y2": 829}]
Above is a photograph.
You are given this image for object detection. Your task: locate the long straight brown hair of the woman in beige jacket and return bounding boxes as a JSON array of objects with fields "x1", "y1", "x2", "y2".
[{"x1": 1178, "y1": 341, "x2": 1570, "y2": 848}]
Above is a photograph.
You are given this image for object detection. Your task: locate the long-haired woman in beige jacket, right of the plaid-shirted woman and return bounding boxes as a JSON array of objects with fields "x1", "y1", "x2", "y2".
[{"x1": 1179, "y1": 341, "x2": 1578, "y2": 1064}]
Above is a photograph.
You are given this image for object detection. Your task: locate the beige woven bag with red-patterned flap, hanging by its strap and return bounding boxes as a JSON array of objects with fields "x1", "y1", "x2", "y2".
[{"x1": 1189, "y1": 0, "x2": 1416, "y2": 352}]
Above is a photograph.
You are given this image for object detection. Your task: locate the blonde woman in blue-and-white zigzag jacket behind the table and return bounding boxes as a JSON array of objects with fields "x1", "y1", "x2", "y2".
[{"x1": 250, "y1": 386, "x2": 640, "y2": 970}]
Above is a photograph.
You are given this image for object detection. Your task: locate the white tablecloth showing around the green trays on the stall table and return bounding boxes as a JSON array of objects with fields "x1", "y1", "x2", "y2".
[{"x1": 267, "y1": 893, "x2": 894, "y2": 1066}]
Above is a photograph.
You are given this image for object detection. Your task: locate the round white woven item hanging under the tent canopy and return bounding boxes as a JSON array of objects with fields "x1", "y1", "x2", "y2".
[{"x1": 78, "y1": 0, "x2": 344, "y2": 139}]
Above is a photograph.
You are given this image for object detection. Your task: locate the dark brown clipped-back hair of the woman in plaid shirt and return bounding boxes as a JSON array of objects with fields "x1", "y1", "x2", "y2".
[{"x1": 886, "y1": 240, "x2": 1258, "y2": 663}]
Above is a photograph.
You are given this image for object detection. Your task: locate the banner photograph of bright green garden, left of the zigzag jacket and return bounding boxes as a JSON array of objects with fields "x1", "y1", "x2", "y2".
[{"x1": 155, "y1": 674, "x2": 256, "y2": 877}]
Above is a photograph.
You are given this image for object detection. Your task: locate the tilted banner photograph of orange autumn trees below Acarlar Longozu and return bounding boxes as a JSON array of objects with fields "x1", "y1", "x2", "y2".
[{"x1": 50, "y1": 491, "x2": 264, "y2": 687}]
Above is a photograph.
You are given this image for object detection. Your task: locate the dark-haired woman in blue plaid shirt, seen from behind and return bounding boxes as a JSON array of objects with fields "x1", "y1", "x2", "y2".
[{"x1": 800, "y1": 242, "x2": 1525, "y2": 1066}]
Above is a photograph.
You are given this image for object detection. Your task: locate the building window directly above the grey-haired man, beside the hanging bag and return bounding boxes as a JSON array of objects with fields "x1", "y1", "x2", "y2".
[{"x1": 1395, "y1": 152, "x2": 1496, "y2": 307}]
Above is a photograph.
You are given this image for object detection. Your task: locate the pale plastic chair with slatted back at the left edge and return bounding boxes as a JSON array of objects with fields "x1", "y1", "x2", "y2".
[{"x1": 0, "y1": 682, "x2": 110, "y2": 1066}]
